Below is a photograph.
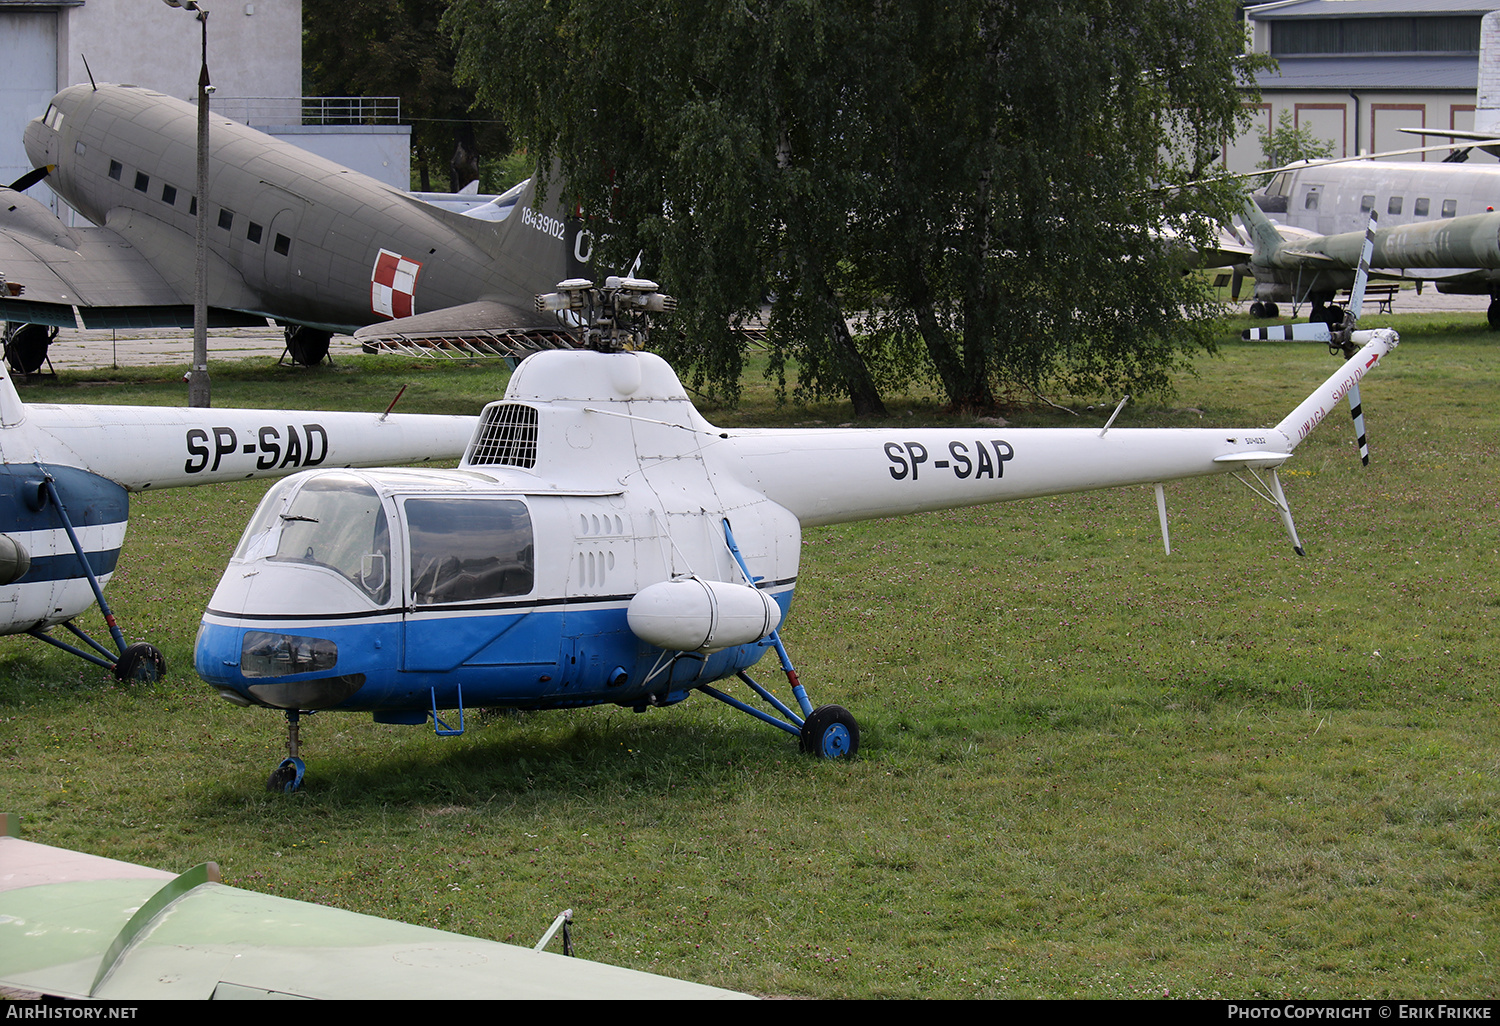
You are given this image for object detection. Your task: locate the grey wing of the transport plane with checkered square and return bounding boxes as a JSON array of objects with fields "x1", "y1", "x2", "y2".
[{"x1": 0, "y1": 189, "x2": 266, "y2": 329}]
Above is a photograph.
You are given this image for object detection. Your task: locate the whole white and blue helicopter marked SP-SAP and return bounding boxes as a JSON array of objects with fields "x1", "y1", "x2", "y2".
[{"x1": 195, "y1": 258, "x2": 1397, "y2": 791}]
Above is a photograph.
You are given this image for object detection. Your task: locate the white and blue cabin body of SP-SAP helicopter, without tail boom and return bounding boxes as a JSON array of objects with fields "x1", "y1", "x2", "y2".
[{"x1": 197, "y1": 353, "x2": 801, "y2": 722}]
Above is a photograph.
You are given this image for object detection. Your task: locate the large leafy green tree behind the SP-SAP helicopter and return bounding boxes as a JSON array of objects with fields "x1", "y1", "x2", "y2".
[{"x1": 447, "y1": 0, "x2": 1266, "y2": 413}]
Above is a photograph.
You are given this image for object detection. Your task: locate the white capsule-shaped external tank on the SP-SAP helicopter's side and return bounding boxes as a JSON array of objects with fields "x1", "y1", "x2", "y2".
[{"x1": 626, "y1": 578, "x2": 782, "y2": 653}]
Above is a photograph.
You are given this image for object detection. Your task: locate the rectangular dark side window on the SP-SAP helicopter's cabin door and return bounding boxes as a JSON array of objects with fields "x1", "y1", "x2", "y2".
[{"x1": 405, "y1": 498, "x2": 536, "y2": 606}]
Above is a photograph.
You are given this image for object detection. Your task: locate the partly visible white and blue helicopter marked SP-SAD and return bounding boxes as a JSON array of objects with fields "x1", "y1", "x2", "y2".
[{"x1": 0, "y1": 368, "x2": 477, "y2": 680}]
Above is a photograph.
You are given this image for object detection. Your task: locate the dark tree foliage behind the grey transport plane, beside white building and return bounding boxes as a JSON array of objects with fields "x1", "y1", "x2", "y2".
[{"x1": 302, "y1": 0, "x2": 510, "y2": 192}]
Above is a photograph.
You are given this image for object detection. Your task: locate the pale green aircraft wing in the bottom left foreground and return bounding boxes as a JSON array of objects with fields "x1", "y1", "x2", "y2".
[{"x1": 0, "y1": 813, "x2": 749, "y2": 1001}]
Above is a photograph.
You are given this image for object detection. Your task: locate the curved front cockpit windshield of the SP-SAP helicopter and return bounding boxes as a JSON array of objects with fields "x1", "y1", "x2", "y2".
[{"x1": 268, "y1": 474, "x2": 390, "y2": 603}]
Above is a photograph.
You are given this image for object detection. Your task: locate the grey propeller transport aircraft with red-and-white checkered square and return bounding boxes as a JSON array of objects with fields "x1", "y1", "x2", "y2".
[{"x1": 0, "y1": 86, "x2": 590, "y2": 374}]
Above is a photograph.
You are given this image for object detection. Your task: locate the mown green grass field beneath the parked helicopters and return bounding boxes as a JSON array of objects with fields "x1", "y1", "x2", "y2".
[{"x1": 0, "y1": 314, "x2": 1500, "y2": 998}]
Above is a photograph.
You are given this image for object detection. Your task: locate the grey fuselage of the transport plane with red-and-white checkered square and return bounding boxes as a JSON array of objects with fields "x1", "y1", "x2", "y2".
[{"x1": 26, "y1": 86, "x2": 566, "y2": 332}]
